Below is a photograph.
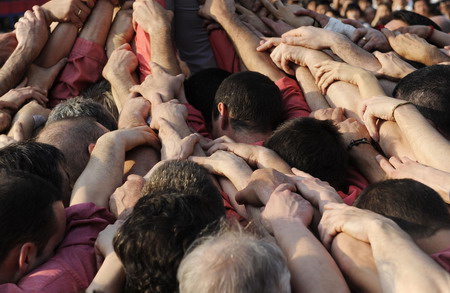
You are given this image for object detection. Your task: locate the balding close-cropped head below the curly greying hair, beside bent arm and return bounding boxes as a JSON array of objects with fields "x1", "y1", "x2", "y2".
[{"x1": 36, "y1": 117, "x2": 106, "y2": 184}]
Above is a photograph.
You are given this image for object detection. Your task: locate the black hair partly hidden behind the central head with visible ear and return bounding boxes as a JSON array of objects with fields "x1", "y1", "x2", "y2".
[{"x1": 184, "y1": 68, "x2": 231, "y2": 127}]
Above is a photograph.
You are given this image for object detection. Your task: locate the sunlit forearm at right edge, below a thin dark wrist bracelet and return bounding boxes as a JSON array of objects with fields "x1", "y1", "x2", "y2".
[{"x1": 395, "y1": 105, "x2": 450, "y2": 172}]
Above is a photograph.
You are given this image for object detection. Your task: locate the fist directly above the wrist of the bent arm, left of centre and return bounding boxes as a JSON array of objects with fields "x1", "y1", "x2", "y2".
[{"x1": 118, "y1": 97, "x2": 150, "y2": 129}]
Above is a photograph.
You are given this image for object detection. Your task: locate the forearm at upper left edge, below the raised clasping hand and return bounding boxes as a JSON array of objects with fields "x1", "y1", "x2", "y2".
[{"x1": 0, "y1": 45, "x2": 34, "y2": 96}]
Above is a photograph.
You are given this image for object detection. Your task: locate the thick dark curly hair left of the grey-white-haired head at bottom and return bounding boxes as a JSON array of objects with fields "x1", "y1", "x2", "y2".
[{"x1": 113, "y1": 191, "x2": 224, "y2": 293}]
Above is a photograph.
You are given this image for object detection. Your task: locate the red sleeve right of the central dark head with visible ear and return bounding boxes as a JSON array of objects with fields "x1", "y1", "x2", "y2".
[{"x1": 275, "y1": 77, "x2": 311, "y2": 121}]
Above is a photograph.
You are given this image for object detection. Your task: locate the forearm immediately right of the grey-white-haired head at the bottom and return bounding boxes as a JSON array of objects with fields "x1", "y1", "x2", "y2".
[{"x1": 272, "y1": 220, "x2": 349, "y2": 292}]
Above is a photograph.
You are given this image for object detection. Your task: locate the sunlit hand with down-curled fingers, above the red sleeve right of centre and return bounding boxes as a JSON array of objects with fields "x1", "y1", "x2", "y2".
[{"x1": 270, "y1": 44, "x2": 310, "y2": 75}]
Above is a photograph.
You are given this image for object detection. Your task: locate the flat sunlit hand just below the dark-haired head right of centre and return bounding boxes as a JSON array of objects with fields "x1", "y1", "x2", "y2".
[{"x1": 288, "y1": 168, "x2": 343, "y2": 213}]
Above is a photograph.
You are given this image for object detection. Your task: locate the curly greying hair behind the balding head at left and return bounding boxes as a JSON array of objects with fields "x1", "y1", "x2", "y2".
[{"x1": 47, "y1": 97, "x2": 117, "y2": 131}]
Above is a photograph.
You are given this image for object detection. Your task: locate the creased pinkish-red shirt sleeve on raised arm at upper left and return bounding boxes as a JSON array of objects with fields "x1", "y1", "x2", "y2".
[{"x1": 47, "y1": 38, "x2": 107, "y2": 108}]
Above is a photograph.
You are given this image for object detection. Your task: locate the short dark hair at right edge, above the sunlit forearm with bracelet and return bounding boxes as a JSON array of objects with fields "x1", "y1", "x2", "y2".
[{"x1": 393, "y1": 65, "x2": 450, "y2": 134}]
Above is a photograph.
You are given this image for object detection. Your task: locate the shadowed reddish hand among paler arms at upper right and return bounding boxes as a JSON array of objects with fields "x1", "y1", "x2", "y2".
[{"x1": 351, "y1": 28, "x2": 392, "y2": 52}]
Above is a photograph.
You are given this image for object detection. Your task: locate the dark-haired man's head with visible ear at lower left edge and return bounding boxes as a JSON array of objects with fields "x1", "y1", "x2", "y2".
[{"x1": 0, "y1": 170, "x2": 66, "y2": 284}]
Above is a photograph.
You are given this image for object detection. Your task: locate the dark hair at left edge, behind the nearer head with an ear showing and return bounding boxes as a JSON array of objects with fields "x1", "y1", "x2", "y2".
[{"x1": 0, "y1": 141, "x2": 65, "y2": 200}]
